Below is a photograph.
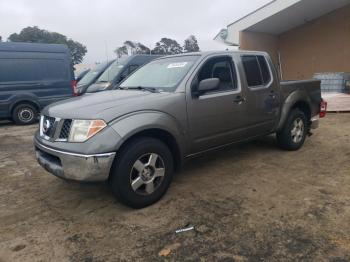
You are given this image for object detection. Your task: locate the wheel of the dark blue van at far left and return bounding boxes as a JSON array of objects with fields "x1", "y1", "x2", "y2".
[{"x1": 12, "y1": 103, "x2": 38, "y2": 125}]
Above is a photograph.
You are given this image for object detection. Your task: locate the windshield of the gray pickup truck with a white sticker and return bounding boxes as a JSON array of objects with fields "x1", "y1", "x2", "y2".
[{"x1": 120, "y1": 56, "x2": 199, "y2": 92}]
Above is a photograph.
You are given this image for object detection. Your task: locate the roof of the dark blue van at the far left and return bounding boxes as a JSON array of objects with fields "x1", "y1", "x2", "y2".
[{"x1": 0, "y1": 42, "x2": 68, "y2": 53}]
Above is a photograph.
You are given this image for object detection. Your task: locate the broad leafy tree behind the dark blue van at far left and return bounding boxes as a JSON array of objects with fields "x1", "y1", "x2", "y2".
[{"x1": 8, "y1": 26, "x2": 87, "y2": 65}]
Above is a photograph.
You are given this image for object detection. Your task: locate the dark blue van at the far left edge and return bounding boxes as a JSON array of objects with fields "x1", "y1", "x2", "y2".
[{"x1": 0, "y1": 43, "x2": 76, "y2": 125}]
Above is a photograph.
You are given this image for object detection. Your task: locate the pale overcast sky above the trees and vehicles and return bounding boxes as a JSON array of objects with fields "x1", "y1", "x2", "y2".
[{"x1": 0, "y1": 0, "x2": 271, "y2": 64}]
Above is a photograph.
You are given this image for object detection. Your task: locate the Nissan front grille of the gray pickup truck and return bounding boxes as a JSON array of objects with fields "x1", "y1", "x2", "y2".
[{"x1": 40, "y1": 116, "x2": 72, "y2": 141}]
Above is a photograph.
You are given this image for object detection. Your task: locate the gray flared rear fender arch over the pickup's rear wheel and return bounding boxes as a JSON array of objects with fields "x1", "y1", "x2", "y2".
[{"x1": 276, "y1": 90, "x2": 311, "y2": 131}]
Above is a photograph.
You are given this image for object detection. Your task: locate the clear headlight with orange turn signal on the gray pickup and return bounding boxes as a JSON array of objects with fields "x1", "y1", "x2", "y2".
[{"x1": 68, "y1": 120, "x2": 107, "y2": 142}]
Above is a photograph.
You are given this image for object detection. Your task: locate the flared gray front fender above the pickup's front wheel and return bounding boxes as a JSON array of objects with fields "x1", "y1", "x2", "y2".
[{"x1": 109, "y1": 111, "x2": 186, "y2": 154}]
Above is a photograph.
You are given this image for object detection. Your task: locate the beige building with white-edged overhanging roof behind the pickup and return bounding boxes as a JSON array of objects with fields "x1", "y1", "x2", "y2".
[{"x1": 215, "y1": 0, "x2": 350, "y2": 80}]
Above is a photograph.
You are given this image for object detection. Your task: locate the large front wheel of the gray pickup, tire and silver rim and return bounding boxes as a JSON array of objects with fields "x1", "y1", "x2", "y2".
[{"x1": 110, "y1": 137, "x2": 174, "y2": 208}]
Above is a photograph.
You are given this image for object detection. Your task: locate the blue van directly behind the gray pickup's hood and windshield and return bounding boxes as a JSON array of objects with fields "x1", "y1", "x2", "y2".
[{"x1": 86, "y1": 55, "x2": 160, "y2": 93}]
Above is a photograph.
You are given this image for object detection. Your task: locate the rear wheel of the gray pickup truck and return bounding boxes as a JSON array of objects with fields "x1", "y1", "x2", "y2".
[{"x1": 277, "y1": 109, "x2": 308, "y2": 151}]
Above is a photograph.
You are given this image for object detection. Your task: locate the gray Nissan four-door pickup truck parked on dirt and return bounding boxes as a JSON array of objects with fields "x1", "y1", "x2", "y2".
[{"x1": 34, "y1": 51, "x2": 326, "y2": 208}]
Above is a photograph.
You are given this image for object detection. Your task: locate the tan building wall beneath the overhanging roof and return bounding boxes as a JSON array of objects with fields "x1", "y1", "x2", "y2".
[{"x1": 240, "y1": 5, "x2": 350, "y2": 79}]
